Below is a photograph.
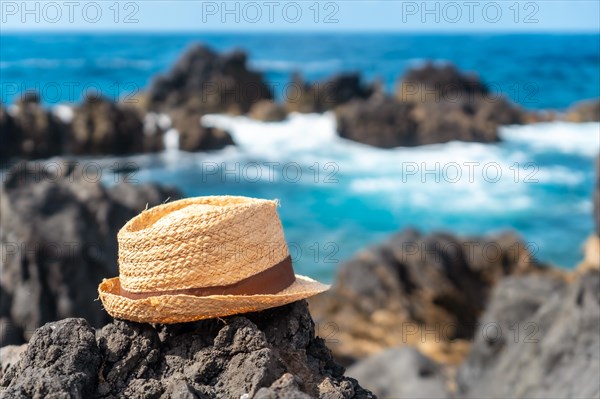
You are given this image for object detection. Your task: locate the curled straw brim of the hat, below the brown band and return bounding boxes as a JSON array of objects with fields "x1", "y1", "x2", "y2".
[{"x1": 98, "y1": 274, "x2": 330, "y2": 324}]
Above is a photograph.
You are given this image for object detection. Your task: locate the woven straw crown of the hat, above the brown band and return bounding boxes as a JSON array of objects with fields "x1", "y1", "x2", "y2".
[{"x1": 118, "y1": 196, "x2": 289, "y2": 293}]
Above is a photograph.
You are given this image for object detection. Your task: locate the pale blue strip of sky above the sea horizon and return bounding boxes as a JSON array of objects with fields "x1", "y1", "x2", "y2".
[{"x1": 0, "y1": 0, "x2": 600, "y2": 32}]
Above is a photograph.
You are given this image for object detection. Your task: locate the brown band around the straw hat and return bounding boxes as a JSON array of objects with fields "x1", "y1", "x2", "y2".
[{"x1": 120, "y1": 256, "x2": 296, "y2": 299}]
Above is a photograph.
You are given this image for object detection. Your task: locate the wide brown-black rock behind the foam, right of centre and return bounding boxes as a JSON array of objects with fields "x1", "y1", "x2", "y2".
[{"x1": 336, "y1": 64, "x2": 526, "y2": 148}]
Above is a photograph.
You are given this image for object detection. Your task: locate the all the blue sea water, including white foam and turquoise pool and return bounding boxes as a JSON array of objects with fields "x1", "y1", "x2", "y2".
[{"x1": 0, "y1": 34, "x2": 600, "y2": 281}]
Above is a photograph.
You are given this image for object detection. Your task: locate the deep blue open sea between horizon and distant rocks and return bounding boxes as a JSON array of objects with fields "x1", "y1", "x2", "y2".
[{"x1": 0, "y1": 33, "x2": 600, "y2": 109}]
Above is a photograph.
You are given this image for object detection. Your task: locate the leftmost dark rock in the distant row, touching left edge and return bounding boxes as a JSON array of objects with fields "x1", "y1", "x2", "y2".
[{"x1": 0, "y1": 93, "x2": 65, "y2": 160}]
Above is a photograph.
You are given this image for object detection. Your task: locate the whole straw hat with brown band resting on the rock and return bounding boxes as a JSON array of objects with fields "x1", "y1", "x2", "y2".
[{"x1": 98, "y1": 196, "x2": 329, "y2": 323}]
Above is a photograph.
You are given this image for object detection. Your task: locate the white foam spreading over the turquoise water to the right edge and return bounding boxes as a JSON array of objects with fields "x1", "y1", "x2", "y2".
[{"x1": 202, "y1": 113, "x2": 600, "y2": 214}]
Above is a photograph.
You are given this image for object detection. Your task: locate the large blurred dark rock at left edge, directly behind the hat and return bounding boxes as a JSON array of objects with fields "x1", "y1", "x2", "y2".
[{"x1": 0, "y1": 161, "x2": 180, "y2": 346}]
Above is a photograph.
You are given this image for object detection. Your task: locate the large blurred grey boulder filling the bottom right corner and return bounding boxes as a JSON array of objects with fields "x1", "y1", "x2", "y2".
[{"x1": 458, "y1": 270, "x2": 600, "y2": 398}]
